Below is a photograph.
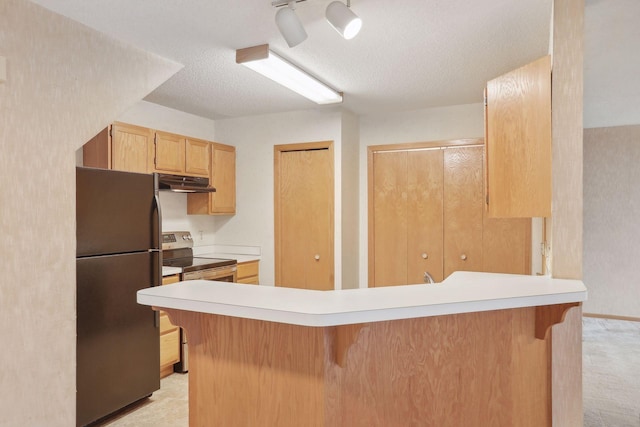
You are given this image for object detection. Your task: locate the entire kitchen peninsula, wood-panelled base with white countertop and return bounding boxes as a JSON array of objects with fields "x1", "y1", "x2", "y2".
[{"x1": 138, "y1": 272, "x2": 587, "y2": 427}]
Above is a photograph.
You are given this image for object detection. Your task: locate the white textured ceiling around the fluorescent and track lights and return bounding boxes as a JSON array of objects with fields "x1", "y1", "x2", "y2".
[{"x1": 28, "y1": 0, "x2": 640, "y2": 127}]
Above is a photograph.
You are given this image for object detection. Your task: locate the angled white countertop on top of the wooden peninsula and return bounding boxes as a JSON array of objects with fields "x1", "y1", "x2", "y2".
[{"x1": 138, "y1": 271, "x2": 587, "y2": 326}]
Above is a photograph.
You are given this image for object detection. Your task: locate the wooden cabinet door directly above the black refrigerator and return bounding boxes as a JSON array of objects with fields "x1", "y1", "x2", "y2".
[{"x1": 111, "y1": 123, "x2": 153, "y2": 173}]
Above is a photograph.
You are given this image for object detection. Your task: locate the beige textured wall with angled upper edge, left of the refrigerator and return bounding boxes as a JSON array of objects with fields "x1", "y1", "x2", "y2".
[{"x1": 0, "y1": 0, "x2": 179, "y2": 426}]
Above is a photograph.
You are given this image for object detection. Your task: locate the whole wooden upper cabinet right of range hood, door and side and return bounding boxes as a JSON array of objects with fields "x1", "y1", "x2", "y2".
[{"x1": 187, "y1": 142, "x2": 236, "y2": 215}]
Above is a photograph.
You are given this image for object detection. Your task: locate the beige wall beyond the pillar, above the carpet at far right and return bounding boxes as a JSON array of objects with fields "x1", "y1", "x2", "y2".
[{"x1": 583, "y1": 125, "x2": 640, "y2": 318}]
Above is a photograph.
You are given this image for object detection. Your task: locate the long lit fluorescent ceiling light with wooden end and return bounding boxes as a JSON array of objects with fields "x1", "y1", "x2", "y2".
[{"x1": 236, "y1": 44, "x2": 342, "y2": 104}]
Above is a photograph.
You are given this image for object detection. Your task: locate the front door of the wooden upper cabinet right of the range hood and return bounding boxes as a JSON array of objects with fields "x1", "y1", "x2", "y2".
[{"x1": 210, "y1": 144, "x2": 236, "y2": 214}]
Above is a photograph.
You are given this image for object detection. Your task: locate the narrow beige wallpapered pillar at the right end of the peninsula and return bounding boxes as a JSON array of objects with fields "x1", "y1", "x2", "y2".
[{"x1": 551, "y1": 0, "x2": 584, "y2": 426}]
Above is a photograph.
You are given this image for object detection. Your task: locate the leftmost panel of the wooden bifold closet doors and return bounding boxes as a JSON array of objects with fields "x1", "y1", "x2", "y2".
[{"x1": 369, "y1": 151, "x2": 408, "y2": 286}]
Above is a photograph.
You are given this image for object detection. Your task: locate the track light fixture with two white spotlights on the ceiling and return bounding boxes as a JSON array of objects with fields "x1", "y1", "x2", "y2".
[{"x1": 271, "y1": 0, "x2": 362, "y2": 47}]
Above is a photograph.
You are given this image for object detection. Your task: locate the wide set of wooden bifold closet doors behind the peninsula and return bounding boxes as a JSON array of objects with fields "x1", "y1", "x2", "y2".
[{"x1": 369, "y1": 139, "x2": 531, "y2": 286}]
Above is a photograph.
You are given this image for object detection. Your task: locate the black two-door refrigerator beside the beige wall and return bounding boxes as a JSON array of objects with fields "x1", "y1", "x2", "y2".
[{"x1": 76, "y1": 167, "x2": 162, "y2": 426}]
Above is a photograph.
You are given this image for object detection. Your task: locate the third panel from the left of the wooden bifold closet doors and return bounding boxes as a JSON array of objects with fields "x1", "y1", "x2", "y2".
[{"x1": 444, "y1": 146, "x2": 484, "y2": 278}]
